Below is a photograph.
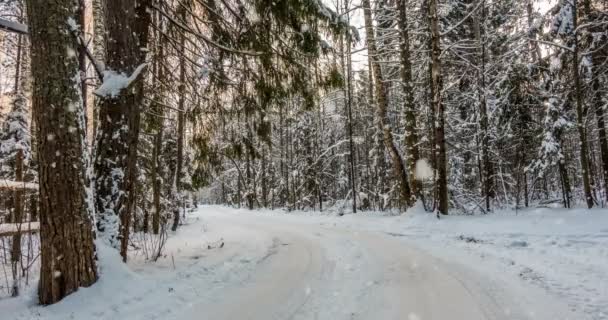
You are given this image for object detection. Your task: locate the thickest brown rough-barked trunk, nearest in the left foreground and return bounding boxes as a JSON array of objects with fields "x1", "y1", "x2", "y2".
[{"x1": 27, "y1": 0, "x2": 97, "y2": 304}]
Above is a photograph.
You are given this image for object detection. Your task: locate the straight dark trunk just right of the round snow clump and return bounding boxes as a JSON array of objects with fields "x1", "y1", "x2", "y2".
[{"x1": 428, "y1": 0, "x2": 449, "y2": 214}]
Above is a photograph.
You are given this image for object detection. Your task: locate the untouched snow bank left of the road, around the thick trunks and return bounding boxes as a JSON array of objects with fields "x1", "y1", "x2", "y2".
[{"x1": 0, "y1": 211, "x2": 272, "y2": 320}]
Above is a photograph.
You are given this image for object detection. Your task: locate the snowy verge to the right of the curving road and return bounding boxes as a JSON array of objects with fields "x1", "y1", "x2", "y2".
[{"x1": 264, "y1": 208, "x2": 608, "y2": 320}]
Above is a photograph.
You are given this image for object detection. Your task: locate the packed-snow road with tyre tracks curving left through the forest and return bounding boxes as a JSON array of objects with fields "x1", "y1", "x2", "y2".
[{"x1": 181, "y1": 208, "x2": 567, "y2": 320}]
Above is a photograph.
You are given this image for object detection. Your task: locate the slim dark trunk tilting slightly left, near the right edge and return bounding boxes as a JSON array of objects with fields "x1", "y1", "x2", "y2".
[{"x1": 572, "y1": 0, "x2": 593, "y2": 208}]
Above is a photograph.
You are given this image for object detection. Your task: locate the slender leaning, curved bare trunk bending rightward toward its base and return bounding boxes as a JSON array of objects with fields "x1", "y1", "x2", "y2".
[{"x1": 361, "y1": 0, "x2": 413, "y2": 207}]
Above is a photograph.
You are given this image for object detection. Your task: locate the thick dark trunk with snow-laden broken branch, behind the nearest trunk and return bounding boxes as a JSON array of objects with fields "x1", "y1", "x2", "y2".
[{"x1": 95, "y1": 0, "x2": 150, "y2": 261}]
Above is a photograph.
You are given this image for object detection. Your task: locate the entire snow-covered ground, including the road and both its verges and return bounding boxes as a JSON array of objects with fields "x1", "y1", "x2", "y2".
[{"x1": 0, "y1": 206, "x2": 608, "y2": 320}]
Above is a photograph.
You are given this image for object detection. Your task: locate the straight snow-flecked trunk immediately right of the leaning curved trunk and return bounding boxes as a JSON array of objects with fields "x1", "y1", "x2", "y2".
[{"x1": 399, "y1": 0, "x2": 421, "y2": 201}]
